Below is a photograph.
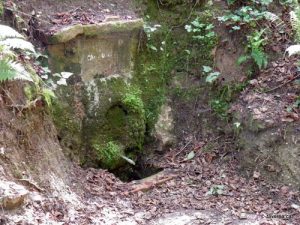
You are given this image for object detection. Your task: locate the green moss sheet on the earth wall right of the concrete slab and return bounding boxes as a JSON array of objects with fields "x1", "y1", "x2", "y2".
[{"x1": 134, "y1": 1, "x2": 217, "y2": 133}]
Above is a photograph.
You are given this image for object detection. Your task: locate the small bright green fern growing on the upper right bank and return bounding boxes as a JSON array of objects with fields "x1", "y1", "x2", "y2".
[{"x1": 237, "y1": 30, "x2": 268, "y2": 69}]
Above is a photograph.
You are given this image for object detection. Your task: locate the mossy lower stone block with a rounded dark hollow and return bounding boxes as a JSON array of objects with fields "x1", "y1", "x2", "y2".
[{"x1": 83, "y1": 77, "x2": 145, "y2": 168}]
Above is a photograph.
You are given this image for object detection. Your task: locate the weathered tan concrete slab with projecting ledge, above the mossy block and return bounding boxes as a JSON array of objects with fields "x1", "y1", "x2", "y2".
[{"x1": 48, "y1": 19, "x2": 143, "y2": 81}]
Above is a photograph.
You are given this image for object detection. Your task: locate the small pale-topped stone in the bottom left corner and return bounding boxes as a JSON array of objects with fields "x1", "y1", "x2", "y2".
[{"x1": 0, "y1": 180, "x2": 29, "y2": 210}]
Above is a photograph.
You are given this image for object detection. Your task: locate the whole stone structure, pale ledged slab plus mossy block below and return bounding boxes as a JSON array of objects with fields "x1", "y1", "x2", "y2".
[{"x1": 47, "y1": 19, "x2": 146, "y2": 170}]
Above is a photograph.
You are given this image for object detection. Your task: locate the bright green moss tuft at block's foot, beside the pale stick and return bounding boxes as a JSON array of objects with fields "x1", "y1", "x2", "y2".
[{"x1": 93, "y1": 141, "x2": 123, "y2": 169}]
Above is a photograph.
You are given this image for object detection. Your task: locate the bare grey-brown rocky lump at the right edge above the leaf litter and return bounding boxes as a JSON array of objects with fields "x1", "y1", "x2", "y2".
[{"x1": 238, "y1": 124, "x2": 300, "y2": 187}]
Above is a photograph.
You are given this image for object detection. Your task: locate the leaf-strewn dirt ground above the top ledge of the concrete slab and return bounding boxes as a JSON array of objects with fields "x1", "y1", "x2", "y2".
[{"x1": 6, "y1": 0, "x2": 136, "y2": 33}]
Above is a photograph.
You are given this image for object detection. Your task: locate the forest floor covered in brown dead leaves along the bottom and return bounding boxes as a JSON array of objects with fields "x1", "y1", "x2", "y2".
[{"x1": 1, "y1": 149, "x2": 300, "y2": 225}]
